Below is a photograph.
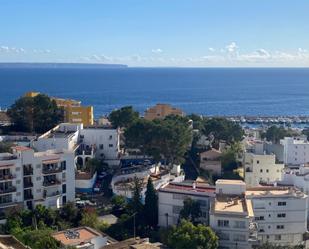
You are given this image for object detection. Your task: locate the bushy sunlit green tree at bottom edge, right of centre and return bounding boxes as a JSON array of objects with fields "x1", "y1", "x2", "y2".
[{"x1": 167, "y1": 220, "x2": 218, "y2": 249}]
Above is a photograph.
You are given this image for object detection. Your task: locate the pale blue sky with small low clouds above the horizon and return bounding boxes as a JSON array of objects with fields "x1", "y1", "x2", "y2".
[{"x1": 0, "y1": 0, "x2": 309, "y2": 67}]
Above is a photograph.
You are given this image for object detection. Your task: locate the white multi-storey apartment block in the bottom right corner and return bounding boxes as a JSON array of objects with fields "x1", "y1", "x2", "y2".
[{"x1": 246, "y1": 187, "x2": 308, "y2": 246}]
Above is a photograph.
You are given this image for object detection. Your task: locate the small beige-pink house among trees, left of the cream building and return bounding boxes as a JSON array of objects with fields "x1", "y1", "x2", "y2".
[{"x1": 200, "y1": 149, "x2": 222, "y2": 175}]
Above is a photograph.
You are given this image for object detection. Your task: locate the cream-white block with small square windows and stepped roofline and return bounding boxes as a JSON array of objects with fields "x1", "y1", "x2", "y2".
[{"x1": 244, "y1": 153, "x2": 284, "y2": 187}]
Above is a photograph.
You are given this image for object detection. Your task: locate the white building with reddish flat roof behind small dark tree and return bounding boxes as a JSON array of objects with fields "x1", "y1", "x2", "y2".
[{"x1": 158, "y1": 182, "x2": 215, "y2": 227}]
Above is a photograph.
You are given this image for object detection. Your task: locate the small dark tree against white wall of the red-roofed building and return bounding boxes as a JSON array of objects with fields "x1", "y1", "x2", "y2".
[{"x1": 179, "y1": 198, "x2": 201, "y2": 223}]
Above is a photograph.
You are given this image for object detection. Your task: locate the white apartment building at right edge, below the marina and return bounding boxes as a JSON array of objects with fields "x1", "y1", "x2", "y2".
[{"x1": 280, "y1": 137, "x2": 309, "y2": 166}]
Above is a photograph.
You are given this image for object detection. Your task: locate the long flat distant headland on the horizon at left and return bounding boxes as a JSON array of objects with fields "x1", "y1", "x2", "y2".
[{"x1": 0, "y1": 63, "x2": 128, "y2": 69}]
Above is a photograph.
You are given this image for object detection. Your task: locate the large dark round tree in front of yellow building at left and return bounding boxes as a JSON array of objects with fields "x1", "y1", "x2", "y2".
[{"x1": 7, "y1": 94, "x2": 63, "y2": 133}]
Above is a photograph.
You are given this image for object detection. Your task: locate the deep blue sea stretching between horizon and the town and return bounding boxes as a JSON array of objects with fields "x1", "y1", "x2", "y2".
[{"x1": 0, "y1": 68, "x2": 309, "y2": 117}]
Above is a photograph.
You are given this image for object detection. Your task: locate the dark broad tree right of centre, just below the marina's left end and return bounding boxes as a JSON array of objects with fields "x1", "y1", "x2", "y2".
[{"x1": 202, "y1": 118, "x2": 244, "y2": 145}]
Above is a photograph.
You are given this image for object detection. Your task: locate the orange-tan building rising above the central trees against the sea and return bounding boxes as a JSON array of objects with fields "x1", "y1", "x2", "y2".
[{"x1": 145, "y1": 104, "x2": 185, "y2": 120}]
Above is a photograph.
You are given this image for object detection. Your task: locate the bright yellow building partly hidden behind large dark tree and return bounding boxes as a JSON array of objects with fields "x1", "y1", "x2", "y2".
[{"x1": 25, "y1": 92, "x2": 93, "y2": 126}]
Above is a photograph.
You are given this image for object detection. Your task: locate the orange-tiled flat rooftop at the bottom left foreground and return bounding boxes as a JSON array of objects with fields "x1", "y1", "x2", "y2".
[{"x1": 52, "y1": 227, "x2": 102, "y2": 246}]
